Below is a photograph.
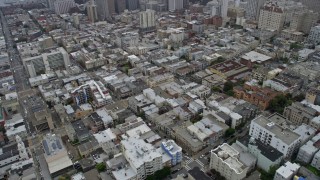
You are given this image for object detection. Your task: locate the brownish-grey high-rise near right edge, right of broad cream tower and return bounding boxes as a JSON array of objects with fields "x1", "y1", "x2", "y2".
[{"x1": 290, "y1": 10, "x2": 319, "y2": 34}]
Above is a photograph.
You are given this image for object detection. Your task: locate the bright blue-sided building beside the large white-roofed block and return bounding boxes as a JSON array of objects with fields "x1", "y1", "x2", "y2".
[{"x1": 161, "y1": 140, "x2": 182, "y2": 166}]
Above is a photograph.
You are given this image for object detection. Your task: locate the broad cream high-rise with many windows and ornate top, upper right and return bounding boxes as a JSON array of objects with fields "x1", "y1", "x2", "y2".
[{"x1": 258, "y1": 3, "x2": 285, "y2": 31}]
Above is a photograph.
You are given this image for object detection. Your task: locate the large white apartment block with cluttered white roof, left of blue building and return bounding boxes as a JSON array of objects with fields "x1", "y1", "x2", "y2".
[{"x1": 121, "y1": 137, "x2": 163, "y2": 179}]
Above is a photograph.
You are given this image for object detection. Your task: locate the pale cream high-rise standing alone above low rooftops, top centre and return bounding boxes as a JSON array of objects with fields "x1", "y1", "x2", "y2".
[{"x1": 139, "y1": 9, "x2": 156, "y2": 32}]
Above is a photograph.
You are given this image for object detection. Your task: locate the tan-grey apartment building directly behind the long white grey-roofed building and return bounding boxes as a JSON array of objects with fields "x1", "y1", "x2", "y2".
[{"x1": 283, "y1": 102, "x2": 317, "y2": 126}]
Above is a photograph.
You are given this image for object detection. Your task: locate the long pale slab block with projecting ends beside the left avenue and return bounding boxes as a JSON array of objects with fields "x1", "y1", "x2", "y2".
[{"x1": 22, "y1": 47, "x2": 70, "y2": 77}]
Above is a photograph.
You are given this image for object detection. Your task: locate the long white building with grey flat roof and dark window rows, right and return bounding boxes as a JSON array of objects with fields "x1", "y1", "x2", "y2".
[{"x1": 249, "y1": 116, "x2": 300, "y2": 158}]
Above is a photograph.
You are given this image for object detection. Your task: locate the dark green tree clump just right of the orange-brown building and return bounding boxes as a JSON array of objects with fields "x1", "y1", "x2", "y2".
[{"x1": 268, "y1": 94, "x2": 292, "y2": 114}]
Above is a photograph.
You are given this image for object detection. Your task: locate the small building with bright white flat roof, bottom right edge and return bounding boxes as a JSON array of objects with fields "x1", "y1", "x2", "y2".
[{"x1": 273, "y1": 161, "x2": 300, "y2": 180}]
